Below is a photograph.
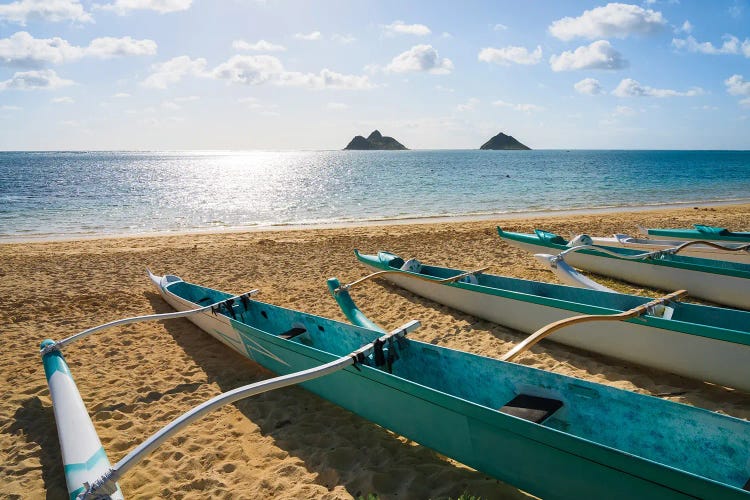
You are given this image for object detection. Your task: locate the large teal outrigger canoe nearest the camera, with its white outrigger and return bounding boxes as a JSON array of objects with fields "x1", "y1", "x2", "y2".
[{"x1": 42, "y1": 275, "x2": 750, "y2": 499}]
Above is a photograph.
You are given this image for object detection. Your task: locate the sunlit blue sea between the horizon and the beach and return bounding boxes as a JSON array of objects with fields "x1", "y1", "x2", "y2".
[{"x1": 0, "y1": 150, "x2": 750, "y2": 241}]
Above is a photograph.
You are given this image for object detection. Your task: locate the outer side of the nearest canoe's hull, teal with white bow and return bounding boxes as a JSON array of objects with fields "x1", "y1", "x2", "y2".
[{"x1": 151, "y1": 276, "x2": 747, "y2": 499}]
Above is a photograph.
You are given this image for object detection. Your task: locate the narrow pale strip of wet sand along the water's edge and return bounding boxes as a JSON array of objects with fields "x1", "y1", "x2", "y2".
[{"x1": 0, "y1": 198, "x2": 750, "y2": 245}]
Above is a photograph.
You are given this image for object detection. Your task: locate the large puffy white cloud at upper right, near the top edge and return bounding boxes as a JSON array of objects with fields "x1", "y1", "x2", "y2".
[{"x1": 549, "y1": 3, "x2": 666, "y2": 41}]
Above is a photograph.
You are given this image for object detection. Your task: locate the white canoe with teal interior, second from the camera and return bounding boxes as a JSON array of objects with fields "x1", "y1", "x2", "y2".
[{"x1": 354, "y1": 250, "x2": 750, "y2": 392}]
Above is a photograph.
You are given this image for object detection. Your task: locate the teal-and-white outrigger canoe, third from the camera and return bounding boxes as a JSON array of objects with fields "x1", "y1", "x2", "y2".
[{"x1": 497, "y1": 227, "x2": 750, "y2": 309}]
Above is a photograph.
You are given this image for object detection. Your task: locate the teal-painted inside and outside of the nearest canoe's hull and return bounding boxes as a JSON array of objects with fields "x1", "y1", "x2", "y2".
[{"x1": 162, "y1": 276, "x2": 750, "y2": 498}]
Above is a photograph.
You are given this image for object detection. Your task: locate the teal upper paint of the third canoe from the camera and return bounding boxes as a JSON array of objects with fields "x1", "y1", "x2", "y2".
[{"x1": 497, "y1": 227, "x2": 750, "y2": 283}]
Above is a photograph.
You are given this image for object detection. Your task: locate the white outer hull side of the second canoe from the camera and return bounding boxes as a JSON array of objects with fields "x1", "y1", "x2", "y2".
[{"x1": 361, "y1": 262, "x2": 750, "y2": 392}]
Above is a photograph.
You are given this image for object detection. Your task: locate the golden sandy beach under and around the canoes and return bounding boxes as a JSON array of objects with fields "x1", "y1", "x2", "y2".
[{"x1": 0, "y1": 205, "x2": 750, "y2": 498}]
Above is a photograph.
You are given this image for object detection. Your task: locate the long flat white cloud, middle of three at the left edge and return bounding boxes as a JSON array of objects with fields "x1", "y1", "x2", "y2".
[{"x1": 0, "y1": 31, "x2": 156, "y2": 67}]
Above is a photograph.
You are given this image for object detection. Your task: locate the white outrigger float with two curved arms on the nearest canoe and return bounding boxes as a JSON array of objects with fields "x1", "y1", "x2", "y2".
[{"x1": 40, "y1": 290, "x2": 420, "y2": 500}]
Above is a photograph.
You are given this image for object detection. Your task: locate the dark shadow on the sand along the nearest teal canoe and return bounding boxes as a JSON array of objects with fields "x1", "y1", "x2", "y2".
[{"x1": 146, "y1": 292, "x2": 528, "y2": 498}]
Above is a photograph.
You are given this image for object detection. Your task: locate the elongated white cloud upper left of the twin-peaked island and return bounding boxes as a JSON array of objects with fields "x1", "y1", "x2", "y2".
[{"x1": 211, "y1": 55, "x2": 374, "y2": 90}]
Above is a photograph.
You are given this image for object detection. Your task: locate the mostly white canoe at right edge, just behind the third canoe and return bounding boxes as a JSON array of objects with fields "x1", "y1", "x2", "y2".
[{"x1": 588, "y1": 234, "x2": 750, "y2": 264}]
